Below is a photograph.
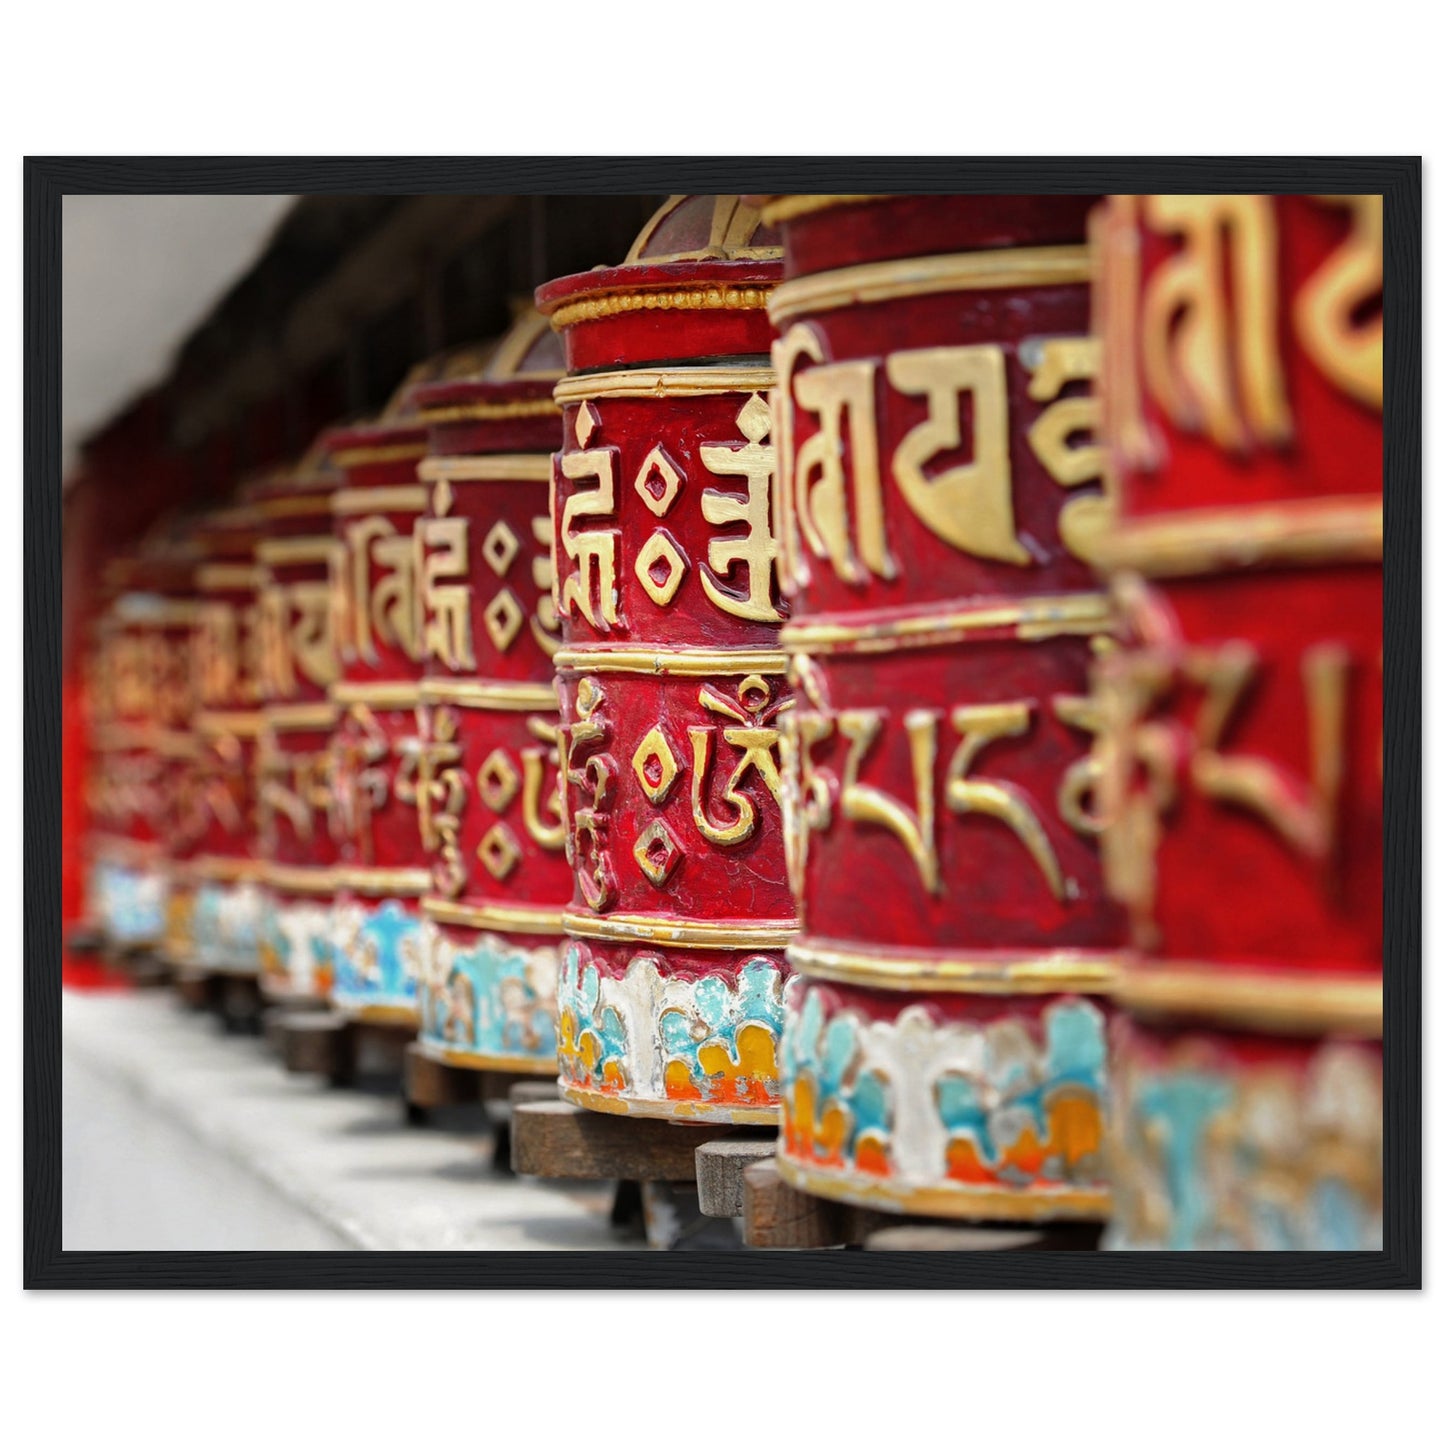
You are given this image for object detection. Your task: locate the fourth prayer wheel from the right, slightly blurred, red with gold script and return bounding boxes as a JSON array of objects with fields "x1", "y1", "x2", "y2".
[{"x1": 403, "y1": 312, "x2": 572, "y2": 1074}]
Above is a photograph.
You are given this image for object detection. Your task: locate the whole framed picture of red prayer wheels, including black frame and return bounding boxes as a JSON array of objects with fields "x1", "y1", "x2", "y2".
[{"x1": 25, "y1": 166, "x2": 1422, "y2": 1289}]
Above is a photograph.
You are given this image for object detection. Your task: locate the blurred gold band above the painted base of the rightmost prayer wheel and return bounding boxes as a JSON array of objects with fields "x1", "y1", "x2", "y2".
[{"x1": 1116, "y1": 962, "x2": 1384, "y2": 1039}]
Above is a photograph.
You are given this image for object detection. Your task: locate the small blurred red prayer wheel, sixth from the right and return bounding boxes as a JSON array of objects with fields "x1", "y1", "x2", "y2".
[{"x1": 250, "y1": 457, "x2": 344, "y2": 998}]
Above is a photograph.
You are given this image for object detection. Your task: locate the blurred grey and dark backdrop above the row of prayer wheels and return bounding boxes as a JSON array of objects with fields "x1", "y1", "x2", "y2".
[{"x1": 61, "y1": 195, "x2": 665, "y2": 959}]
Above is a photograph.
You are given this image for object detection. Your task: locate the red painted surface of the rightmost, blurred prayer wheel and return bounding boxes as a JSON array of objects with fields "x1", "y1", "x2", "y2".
[{"x1": 1105, "y1": 197, "x2": 1384, "y2": 972}]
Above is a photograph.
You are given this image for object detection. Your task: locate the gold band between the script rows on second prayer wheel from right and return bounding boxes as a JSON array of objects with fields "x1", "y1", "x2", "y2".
[{"x1": 782, "y1": 592, "x2": 1114, "y2": 653}]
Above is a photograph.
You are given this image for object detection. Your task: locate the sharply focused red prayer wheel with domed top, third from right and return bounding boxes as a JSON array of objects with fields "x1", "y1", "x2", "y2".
[{"x1": 538, "y1": 197, "x2": 793, "y2": 1123}]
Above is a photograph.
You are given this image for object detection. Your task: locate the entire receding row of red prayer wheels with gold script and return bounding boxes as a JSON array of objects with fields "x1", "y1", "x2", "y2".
[{"x1": 82, "y1": 197, "x2": 1383, "y2": 1248}]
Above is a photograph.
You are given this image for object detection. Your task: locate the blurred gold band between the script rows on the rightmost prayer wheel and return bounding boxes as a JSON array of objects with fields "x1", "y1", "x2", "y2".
[{"x1": 1098, "y1": 497, "x2": 1384, "y2": 577}]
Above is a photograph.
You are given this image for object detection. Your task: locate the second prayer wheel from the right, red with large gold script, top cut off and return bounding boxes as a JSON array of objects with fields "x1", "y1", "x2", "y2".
[{"x1": 763, "y1": 197, "x2": 1123, "y2": 1220}]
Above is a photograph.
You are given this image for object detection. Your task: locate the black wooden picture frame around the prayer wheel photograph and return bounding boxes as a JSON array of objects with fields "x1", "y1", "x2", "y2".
[{"x1": 23, "y1": 156, "x2": 1422, "y2": 1289}]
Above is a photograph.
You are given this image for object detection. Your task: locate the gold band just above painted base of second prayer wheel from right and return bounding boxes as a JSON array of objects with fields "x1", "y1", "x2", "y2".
[{"x1": 788, "y1": 939, "x2": 1124, "y2": 994}]
